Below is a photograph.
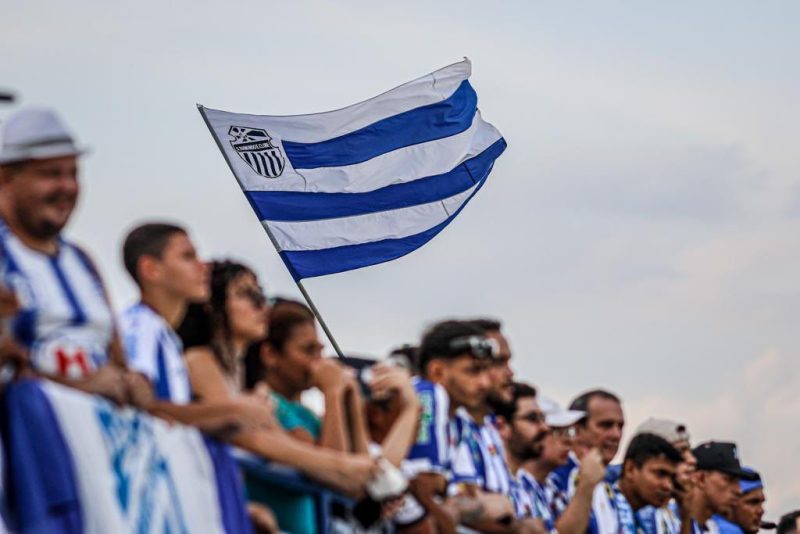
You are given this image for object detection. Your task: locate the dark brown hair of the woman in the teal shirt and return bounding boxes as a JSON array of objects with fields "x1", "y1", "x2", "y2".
[{"x1": 244, "y1": 298, "x2": 315, "y2": 389}]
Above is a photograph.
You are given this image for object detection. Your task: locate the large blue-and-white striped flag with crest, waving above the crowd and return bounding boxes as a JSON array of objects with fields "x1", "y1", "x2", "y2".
[{"x1": 199, "y1": 59, "x2": 506, "y2": 280}]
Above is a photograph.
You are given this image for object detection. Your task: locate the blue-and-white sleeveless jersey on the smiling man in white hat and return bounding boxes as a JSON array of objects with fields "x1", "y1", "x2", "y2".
[{"x1": 0, "y1": 221, "x2": 114, "y2": 378}]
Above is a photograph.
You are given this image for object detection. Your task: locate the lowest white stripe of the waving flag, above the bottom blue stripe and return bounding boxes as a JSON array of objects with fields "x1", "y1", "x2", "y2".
[{"x1": 262, "y1": 184, "x2": 478, "y2": 250}]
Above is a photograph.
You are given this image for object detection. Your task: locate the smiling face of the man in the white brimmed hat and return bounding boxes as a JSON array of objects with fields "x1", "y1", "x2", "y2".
[{"x1": 2, "y1": 156, "x2": 79, "y2": 239}]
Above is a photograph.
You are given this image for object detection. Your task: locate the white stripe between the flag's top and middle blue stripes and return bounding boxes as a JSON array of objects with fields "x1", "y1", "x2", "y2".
[{"x1": 302, "y1": 113, "x2": 502, "y2": 193}]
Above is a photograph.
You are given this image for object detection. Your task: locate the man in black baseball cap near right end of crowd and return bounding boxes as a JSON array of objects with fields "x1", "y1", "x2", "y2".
[{"x1": 686, "y1": 441, "x2": 756, "y2": 534}]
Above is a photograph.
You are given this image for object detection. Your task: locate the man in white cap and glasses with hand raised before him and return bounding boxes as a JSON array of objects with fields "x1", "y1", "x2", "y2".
[{"x1": 518, "y1": 397, "x2": 605, "y2": 533}]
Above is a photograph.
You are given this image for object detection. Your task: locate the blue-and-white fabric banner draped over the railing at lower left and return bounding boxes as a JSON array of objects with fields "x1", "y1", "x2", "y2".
[{"x1": 3, "y1": 380, "x2": 250, "y2": 534}]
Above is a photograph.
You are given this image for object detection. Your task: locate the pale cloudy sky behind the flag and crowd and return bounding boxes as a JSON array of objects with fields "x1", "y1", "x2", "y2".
[{"x1": 0, "y1": 0, "x2": 800, "y2": 519}]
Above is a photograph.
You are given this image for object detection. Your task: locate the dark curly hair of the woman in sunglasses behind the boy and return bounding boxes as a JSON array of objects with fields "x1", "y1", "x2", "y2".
[{"x1": 177, "y1": 260, "x2": 255, "y2": 372}]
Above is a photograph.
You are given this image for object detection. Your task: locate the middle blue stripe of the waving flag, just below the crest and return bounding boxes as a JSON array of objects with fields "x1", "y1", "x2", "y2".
[{"x1": 245, "y1": 138, "x2": 506, "y2": 221}]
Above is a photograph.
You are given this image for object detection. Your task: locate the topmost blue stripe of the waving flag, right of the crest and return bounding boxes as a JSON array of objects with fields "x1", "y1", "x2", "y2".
[{"x1": 282, "y1": 80, "x2": 478, "y2": 169}]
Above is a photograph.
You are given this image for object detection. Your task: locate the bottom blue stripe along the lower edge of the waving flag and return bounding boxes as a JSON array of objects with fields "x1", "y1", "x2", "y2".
[{"x1": 280, "y1": 158, "x2": 492, "y2": 280}]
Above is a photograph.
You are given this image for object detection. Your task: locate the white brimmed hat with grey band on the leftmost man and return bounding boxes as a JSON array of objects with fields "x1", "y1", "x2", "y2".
[{"x1": 0, "y1": 108, "x2": 86, "y2": 165}]
